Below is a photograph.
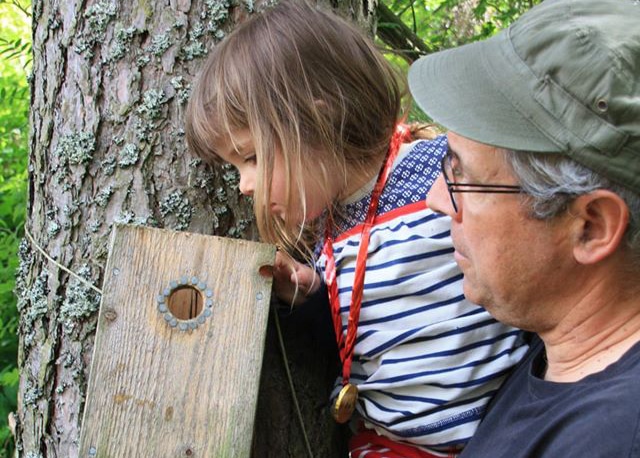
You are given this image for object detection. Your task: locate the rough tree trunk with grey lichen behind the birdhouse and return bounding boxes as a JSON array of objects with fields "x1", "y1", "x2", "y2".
[{"x1": 16, "y1": 0, "x2": 374, "y2": 458}]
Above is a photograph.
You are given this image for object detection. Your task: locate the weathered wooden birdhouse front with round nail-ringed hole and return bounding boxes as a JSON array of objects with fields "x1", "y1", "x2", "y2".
[{"x1": 80, "y1": 226, "x2": 275, "y2": 458}]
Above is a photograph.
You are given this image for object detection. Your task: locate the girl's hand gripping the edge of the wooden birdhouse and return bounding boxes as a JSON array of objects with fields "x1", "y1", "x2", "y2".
[{"x1": 272, "y1": 251, "x2": 320, "y2": 305}]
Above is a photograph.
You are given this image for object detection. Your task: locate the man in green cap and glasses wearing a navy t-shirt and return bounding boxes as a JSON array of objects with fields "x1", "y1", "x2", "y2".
[{"x1": 409, "y1": 0, "x2": 640, "y2": 458}]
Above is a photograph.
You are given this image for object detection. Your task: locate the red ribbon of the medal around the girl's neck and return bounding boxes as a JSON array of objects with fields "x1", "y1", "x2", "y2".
[{"x1": 323, "y1": 124, "x2": 410, "y2": 385}]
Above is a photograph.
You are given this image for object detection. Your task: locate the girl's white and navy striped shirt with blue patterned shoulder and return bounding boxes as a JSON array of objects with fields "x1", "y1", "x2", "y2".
[{"x1": 318, "y1": 136, "x2": 526, "y2": 450}]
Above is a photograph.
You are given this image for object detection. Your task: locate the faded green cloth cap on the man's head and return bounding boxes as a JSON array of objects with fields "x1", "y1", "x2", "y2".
[{"x1": 409, "y1": 0, "x2": 640, "y2": 193}]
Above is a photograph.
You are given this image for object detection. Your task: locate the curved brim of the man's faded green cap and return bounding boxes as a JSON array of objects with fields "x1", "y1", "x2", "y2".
[{"x1": 409, "y1": 33, "x2": 561, "y2": 152}]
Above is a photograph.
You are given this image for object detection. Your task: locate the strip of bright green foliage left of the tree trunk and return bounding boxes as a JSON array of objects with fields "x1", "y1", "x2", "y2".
[{"x1": 0, "y1": 0, "x2": 31, "y2": 458}]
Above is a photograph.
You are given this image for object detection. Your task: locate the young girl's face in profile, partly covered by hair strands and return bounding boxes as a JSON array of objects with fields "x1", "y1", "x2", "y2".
[{"x1": 215, "y1": 129, "x2": 335, "y2": 224}]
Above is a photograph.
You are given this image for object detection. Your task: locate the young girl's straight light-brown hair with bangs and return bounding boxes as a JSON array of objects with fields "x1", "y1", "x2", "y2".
[{"x1": 186, "y1": 0, "x2": 403, "y2": 258}]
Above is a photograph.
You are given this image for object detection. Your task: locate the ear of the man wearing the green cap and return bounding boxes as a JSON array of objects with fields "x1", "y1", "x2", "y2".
[{"x1": 570, "y1": 189, "x2": 629, "y2": 264}]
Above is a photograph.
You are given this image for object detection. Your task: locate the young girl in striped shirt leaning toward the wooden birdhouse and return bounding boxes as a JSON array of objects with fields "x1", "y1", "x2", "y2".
[{"x1": 186, "y1": 1, "x2": 525, "y2": 458}]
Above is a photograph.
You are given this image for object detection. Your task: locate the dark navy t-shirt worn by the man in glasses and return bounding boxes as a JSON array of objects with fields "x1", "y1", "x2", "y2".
[{"x1": 461, "y1": 338, "x2": 640, "y2": 458}]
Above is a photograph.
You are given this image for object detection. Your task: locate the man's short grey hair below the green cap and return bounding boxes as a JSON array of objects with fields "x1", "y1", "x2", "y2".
[{"x1": 505, "y1": 151, "x2": 640, "y2": 266}]
